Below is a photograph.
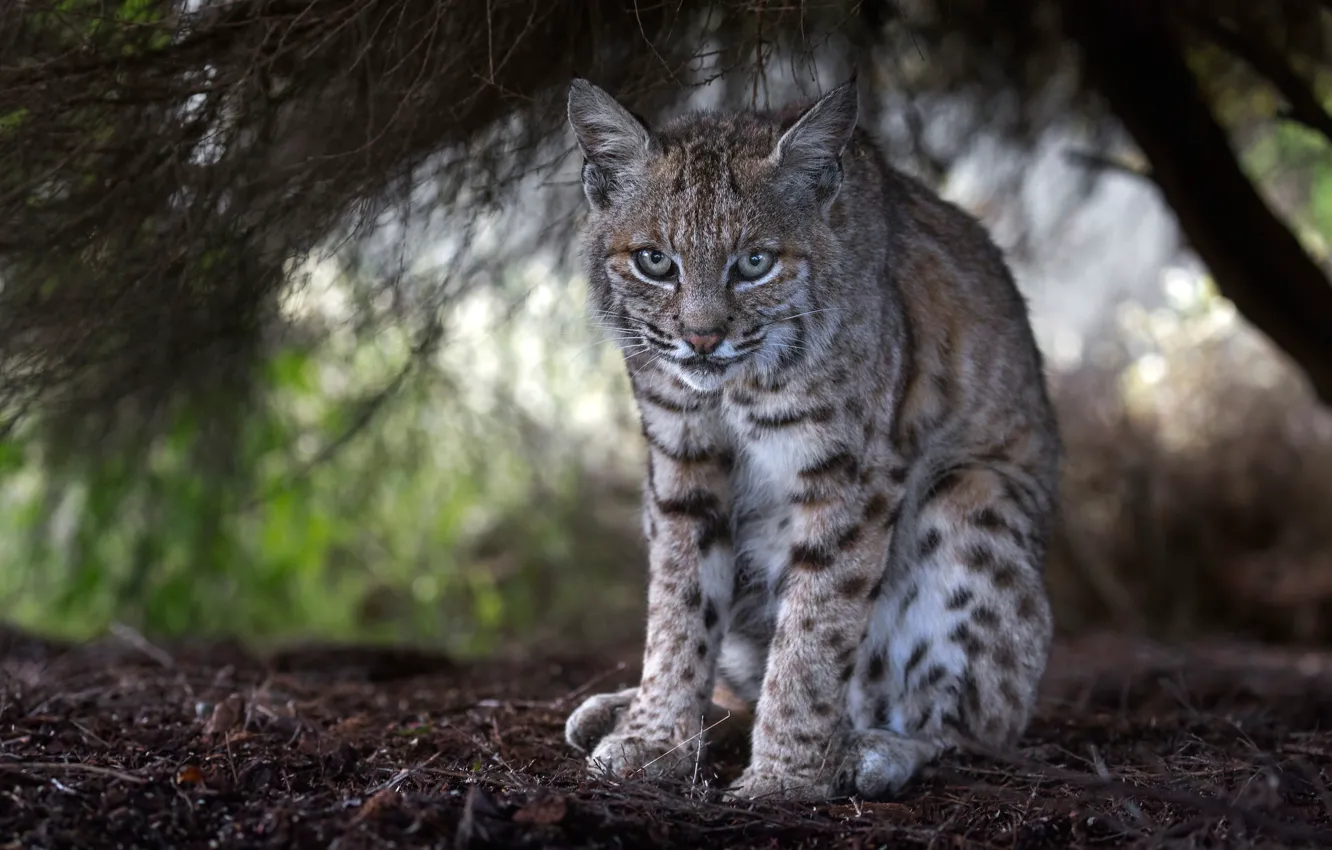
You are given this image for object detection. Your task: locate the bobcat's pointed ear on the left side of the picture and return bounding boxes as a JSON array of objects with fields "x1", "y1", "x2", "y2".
[{"x1": 569, "y1": 79, "x2": 651, "y2": 208}]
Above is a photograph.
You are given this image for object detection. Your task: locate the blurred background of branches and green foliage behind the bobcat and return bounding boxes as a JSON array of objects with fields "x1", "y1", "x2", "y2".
[{"x1": 0, "y1": 0, "x2": 1332, "y2": 654}]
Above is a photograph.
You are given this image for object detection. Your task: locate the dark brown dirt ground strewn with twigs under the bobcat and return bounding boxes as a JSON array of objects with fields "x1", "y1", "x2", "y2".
[{"x1": 0, "y1": 634, "x2": 1332, "y2": 850}]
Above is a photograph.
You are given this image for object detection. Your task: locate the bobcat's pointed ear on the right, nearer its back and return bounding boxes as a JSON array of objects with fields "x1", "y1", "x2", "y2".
[{"x1": 771, "y1": 75, "x2": 859, "y2": 207}]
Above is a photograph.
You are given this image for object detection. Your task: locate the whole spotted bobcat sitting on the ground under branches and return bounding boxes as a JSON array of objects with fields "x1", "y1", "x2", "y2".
[{"x1": 565, "y1": 77, "x2": 1060, "y2": 801}]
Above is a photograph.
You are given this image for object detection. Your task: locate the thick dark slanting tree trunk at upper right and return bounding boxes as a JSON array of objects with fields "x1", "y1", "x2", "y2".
[{"x1": 1063, "y1": 0, "x2": 1332, "y2": 404}]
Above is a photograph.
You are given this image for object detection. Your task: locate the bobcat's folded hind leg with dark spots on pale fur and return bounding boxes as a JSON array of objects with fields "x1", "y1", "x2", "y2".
[{"x1": 838, "y1": 468, "x2": 1052, "y2": 798}]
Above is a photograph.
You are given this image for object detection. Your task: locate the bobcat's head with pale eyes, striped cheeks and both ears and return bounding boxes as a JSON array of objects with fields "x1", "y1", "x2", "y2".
[{"x1": 573, "y1": 83, "x2": 854, "y2": 392}]
